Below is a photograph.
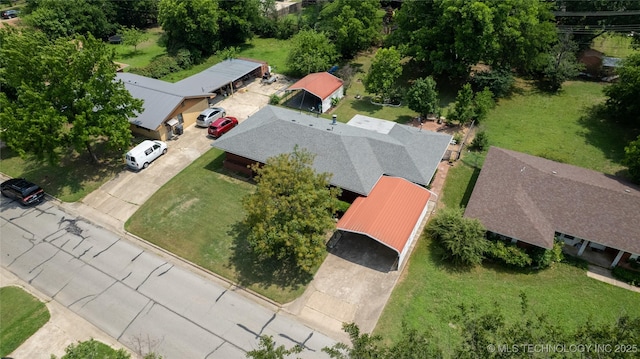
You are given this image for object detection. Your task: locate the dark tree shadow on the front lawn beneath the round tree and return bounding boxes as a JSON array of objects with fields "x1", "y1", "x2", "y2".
[{"x1": 228, "y1": 221, "x2": 313, "y2": 291}]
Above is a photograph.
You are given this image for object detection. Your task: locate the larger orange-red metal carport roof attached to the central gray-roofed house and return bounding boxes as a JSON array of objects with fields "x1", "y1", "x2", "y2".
[{"x1": 337, "y1": 176, "x2": 431, "y2": 255}]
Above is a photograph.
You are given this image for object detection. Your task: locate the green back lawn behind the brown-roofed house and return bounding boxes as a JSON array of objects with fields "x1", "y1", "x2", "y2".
[{"x1": 481, "y1": 81, "x2": 632, "y2": 174}]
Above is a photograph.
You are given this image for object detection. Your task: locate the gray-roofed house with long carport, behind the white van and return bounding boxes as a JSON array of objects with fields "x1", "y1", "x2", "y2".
[{"x1": 116, "y1": 59, "x2": 267, "y2": 140}]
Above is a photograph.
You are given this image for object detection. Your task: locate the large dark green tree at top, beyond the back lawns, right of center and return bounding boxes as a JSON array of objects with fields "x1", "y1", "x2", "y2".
[{"x1": 389, "y1": 0, "x2": 556, "y2": 78}]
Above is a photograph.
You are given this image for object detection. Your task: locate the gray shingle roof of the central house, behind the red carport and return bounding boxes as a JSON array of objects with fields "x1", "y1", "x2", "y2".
[{"x1": 213, "y1": 106, "x2": 451, "y2": 195}]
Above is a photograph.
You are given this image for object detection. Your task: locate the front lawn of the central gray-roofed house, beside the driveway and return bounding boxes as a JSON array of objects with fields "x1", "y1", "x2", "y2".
[{"x1": 126, "y1": 148, "x2": 304, "y2": 303}]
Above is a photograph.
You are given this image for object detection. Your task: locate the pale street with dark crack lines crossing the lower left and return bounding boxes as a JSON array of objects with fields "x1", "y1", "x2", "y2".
[{"x1": 0, "y1": 198, "x2": 335, "y2": 359}]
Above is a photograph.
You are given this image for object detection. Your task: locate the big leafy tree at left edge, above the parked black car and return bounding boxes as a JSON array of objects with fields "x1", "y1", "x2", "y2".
[{"x1": 0, "y1": 30, "x2": 142, "y2": 163}]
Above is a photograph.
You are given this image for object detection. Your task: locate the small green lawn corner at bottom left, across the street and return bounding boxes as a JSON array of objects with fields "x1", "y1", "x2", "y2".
[{"x1": 0, "y1": 287, "x2": 50, "y2": 357}]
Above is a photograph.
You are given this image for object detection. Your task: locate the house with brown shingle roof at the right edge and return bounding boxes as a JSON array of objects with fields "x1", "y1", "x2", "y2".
[{"x1": 464, "y1": 147, "x2": 640, "y2": 267}]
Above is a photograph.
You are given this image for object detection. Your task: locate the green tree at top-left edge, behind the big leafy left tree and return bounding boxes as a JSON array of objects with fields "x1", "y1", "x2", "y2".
[{"x1": 24, "y1": 0, "x2": 118, "y2": 39}]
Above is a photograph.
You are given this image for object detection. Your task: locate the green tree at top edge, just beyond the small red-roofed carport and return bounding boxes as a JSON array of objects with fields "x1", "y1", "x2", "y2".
[{"x1": 316, "y1": 0, "x2": 382, "y2": 58}]
